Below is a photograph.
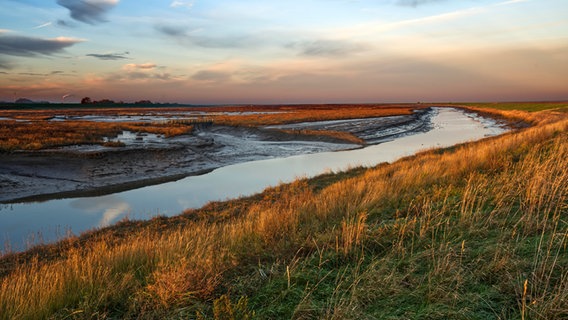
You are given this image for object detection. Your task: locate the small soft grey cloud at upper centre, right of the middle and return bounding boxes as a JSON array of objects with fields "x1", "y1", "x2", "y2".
[{"x1": 287, "y1": 40, "x2": 368, "y2": 57}]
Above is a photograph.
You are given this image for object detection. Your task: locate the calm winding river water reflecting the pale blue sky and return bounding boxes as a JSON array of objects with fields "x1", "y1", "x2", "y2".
[{"x1": 0, "y1": 108, "x2": 505, "y2": 252}]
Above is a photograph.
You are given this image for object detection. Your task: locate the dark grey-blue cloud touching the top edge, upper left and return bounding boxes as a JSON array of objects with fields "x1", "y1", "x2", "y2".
[{"x1": 57, "y1": 0, "x2": 118, "y2": 24}]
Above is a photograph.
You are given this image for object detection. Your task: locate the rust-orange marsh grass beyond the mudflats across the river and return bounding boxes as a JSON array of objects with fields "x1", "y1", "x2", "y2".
[{"x1": 0, "y1": 105, "x2": 415, "y2": 151}]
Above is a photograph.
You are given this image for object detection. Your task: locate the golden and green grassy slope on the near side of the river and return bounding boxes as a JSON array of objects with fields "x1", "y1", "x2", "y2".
[{"x1": 0, "y1": 104, "x2": 568, "y2": 319}]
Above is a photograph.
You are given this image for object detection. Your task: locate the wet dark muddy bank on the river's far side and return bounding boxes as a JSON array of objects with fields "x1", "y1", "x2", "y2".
[{"x1": 0, "y1": 110, "x2": 431, "y2": 203}]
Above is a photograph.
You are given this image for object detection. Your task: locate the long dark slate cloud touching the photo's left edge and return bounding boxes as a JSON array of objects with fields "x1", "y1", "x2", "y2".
[{"x1": 0, "y1": 33, "x2": 83, "y2": 57}]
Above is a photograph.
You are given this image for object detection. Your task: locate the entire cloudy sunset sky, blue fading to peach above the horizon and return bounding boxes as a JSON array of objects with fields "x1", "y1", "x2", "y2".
[{"x1": 0, "y1": 0, "x2": 568, "y2": 104}]
